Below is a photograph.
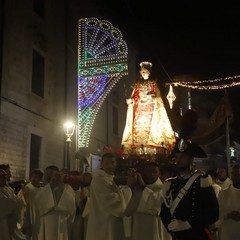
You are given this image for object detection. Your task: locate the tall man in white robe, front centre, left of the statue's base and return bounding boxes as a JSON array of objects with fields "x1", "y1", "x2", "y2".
[{"x1": 86, "y1": 153, "x2": 132, "y2": 240}]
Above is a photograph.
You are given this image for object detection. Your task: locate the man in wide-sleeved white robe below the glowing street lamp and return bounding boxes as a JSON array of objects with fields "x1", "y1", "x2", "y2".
[{"x1": 35, "y1": 172, "x2": 76, "y2": 240}]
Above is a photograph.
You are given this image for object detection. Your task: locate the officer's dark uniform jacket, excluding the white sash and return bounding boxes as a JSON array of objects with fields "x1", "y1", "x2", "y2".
[{"x1": 160, "y1": 171, "x2": 219, "y2": 240}]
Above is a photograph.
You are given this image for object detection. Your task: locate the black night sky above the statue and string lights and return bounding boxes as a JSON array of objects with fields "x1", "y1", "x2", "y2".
[{"x1": 94, "y1": 0, "x2": 240, "y2": 142}]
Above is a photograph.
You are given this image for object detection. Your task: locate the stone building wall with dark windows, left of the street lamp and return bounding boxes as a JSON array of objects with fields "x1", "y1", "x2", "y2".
[{"x1": 0, "y1": 0, "x2": 66, "y2": 180}]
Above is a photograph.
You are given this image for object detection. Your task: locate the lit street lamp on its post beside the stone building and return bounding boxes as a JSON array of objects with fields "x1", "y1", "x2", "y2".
[{"x1": 64, "y1": 121, "x2": 75, "y2": 170}]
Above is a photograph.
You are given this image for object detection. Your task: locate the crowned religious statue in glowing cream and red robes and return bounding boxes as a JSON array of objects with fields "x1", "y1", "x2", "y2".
[{"x1": 122, "y1": 61, "x2": 175, "y2": 154}]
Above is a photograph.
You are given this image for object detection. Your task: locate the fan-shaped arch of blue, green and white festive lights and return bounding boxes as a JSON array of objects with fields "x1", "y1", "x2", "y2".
[{"x1": 78, "y1": 17, "x2": 128, "y2": 148}]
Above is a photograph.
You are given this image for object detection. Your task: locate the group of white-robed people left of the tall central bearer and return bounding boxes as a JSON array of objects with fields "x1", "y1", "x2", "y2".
[{"x1": 0, "y1": 164, "x2": 92, "y2": 240}]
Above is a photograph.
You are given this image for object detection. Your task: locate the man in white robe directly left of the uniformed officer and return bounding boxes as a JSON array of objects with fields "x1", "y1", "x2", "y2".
[{"x1": 126, "y1": 162, "x2": 172, "y2": 240}]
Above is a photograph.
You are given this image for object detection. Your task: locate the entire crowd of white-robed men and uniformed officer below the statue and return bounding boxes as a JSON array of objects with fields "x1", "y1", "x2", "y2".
[{"x1": 0, "y1": 142, "x2": 240, "y2": 240}]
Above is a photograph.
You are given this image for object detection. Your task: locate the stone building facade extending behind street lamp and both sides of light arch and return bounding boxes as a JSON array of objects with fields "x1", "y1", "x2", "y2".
[{"x1": 0, "y1": 0, "x2": 138, "y2": 180}]
